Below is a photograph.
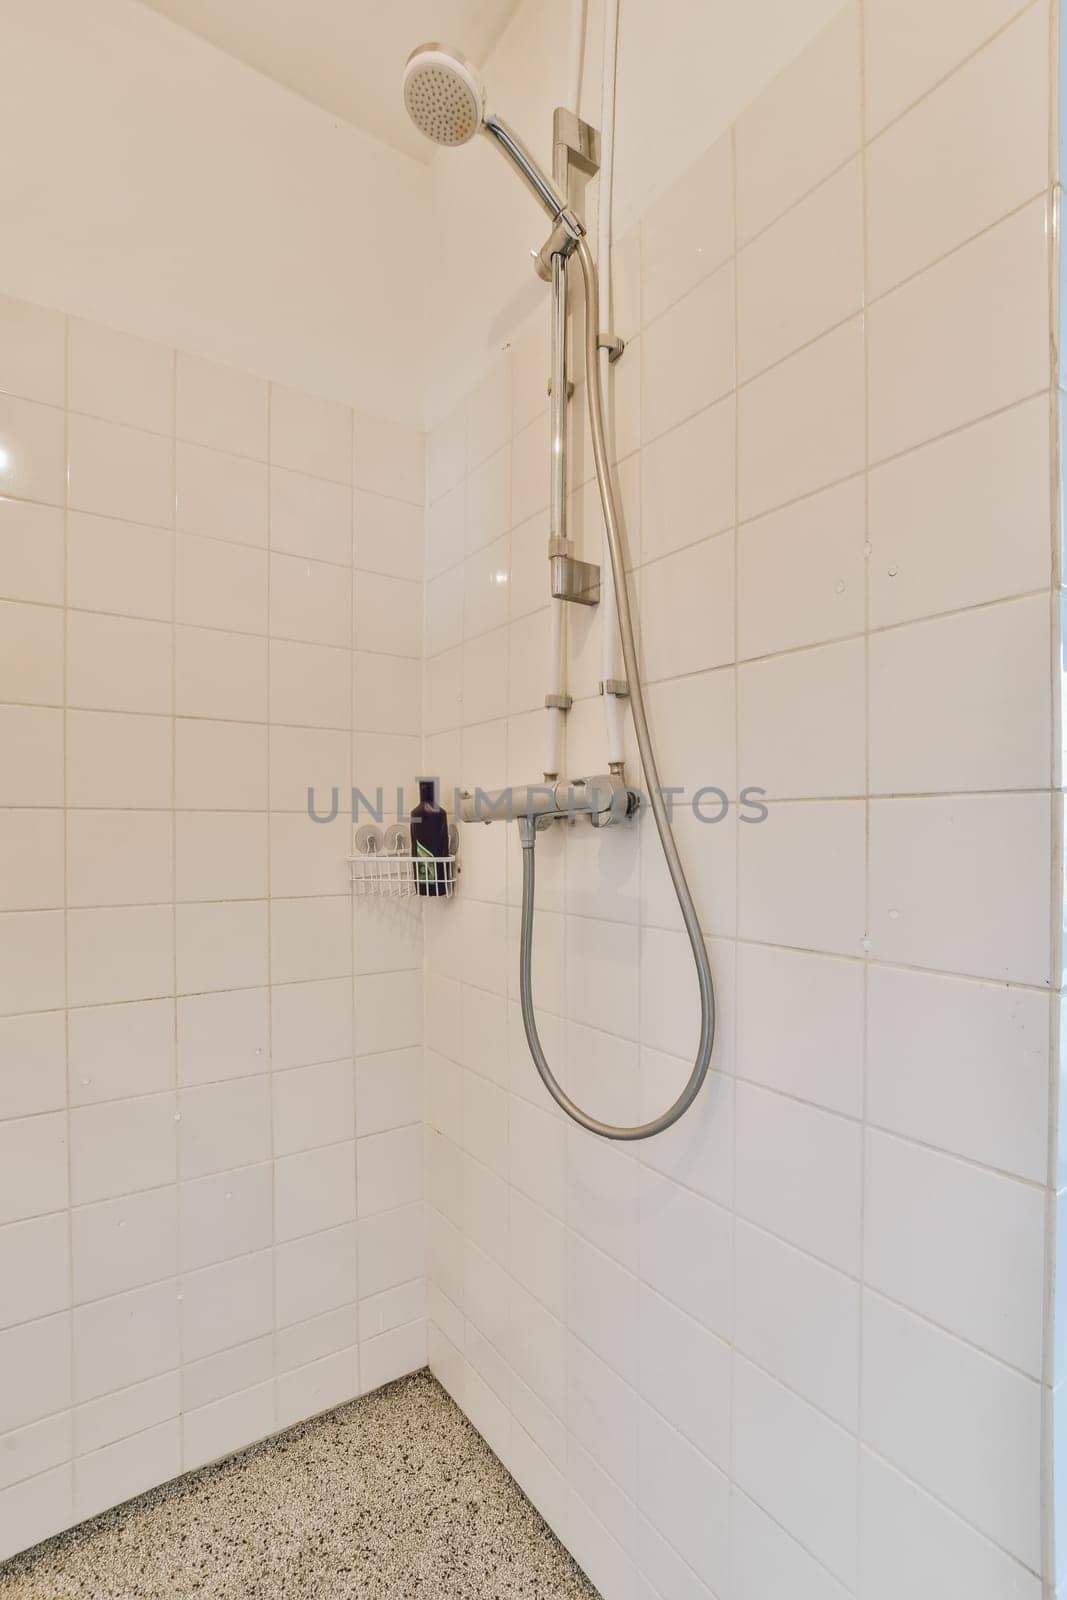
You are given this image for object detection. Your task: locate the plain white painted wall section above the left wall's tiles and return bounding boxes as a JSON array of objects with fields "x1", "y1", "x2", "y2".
[{"x1": 0, "y1": 0, "x2": 427, "y2": 421}]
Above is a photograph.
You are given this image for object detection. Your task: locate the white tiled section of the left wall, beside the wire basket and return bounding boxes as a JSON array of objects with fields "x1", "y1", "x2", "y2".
[{"x1": 0, "y1": 301, "x2": 426, "y2": 1557}]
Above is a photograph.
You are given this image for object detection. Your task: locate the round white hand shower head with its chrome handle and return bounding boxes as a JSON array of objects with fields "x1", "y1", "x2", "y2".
[{"x1": 403, "y1": 43, "x2": 584, "y2": 238}]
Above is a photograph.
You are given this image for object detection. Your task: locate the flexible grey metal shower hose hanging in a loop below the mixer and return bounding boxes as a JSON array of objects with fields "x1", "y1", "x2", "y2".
[{"x1": 518, "y1": 237, "x2": 715, "y2": 1139}]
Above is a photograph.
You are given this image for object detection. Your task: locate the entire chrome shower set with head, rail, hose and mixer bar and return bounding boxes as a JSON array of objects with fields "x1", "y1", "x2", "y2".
[{"x1": 403, "y1": 34, "x2": 715, "y2": 1141}]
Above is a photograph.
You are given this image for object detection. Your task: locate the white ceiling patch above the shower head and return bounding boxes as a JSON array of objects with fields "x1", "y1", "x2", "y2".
[{"x1": 144, "y1": 0, "x2": 518, "y2": 162}]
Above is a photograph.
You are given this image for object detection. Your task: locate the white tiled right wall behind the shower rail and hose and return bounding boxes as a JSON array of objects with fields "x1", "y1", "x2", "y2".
[{"x1": 426, "y1": 0, "x2": 1059, "y2": 1600}]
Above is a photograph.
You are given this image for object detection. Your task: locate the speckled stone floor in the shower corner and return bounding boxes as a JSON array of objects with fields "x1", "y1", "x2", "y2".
[{"x1": 0, "y1": 1373, "x2": 597, "y2": 1600}]
